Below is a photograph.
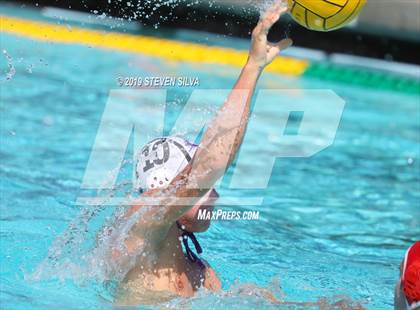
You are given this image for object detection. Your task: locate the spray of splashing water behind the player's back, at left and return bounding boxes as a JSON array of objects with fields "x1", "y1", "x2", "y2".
[{"x1": 26, "y1": 160, "x2": 148, "y2": 283}]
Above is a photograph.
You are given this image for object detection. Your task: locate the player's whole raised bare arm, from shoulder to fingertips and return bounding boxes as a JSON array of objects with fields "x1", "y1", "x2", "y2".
[{"x1": 131, "y1": 3, "x2": 292, "y2": 237}]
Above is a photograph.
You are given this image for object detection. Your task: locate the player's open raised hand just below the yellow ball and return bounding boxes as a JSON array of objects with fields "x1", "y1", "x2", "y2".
[{"x1": 248, "y1": 1, "x2": 293, "y2": 69}]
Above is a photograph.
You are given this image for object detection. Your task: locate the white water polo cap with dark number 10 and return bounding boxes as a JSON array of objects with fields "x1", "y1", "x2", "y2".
[{"x1": 136, "y1": 137, "x2": 198, "y2": 191}]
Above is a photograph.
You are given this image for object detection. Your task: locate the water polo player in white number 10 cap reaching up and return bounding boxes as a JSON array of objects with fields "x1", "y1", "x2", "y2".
[{"x1": 110, "y1": 4, "x2": 292, "y2": 305}]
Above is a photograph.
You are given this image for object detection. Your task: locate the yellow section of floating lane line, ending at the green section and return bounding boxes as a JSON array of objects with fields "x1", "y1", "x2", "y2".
[{"x1": 0, "y1": 16, "x2": 309, "y2": 76}]
